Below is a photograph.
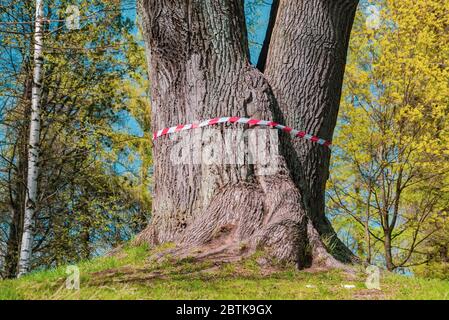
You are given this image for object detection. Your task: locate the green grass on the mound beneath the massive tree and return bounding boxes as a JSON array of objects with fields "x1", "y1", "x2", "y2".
[{"x1": 0, "y1": 246, "x2": 449, "y2": 300}]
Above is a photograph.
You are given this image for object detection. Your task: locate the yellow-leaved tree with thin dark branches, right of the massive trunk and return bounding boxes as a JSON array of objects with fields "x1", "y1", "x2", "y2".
[{"x1": 329, "y1": 0, "x2": 449, "y2": 270}]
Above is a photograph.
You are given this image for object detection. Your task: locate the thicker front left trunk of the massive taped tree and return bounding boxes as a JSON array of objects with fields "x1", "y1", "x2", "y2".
[{"x1": 138, "y1": 0, "x2": 356, "y2": 267}]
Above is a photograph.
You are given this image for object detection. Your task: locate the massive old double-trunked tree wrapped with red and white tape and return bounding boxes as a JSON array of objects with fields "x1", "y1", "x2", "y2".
[{"x1": 138, "y1": 0, "x2": 358, "y2": 267}]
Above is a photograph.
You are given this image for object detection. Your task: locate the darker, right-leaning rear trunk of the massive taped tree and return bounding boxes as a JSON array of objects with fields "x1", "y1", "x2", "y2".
[{"x1": 265, "y1": 0, "x2": 358, "y2": 260}]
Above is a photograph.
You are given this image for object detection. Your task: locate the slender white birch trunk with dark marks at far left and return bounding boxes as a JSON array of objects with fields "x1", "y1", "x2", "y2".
[{"x1": 18, "y1": 0, "x2": 43, "y2": 277}]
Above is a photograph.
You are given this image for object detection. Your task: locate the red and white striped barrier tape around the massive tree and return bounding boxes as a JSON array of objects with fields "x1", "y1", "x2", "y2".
[{"x1": 153, "y1": 117, "x2": 332, "y2": 148}]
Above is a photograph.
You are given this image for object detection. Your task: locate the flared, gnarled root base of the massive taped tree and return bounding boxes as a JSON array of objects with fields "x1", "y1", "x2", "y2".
[{"x1": 136, "y1": 176, "x2": 356, "y2": 270}]
